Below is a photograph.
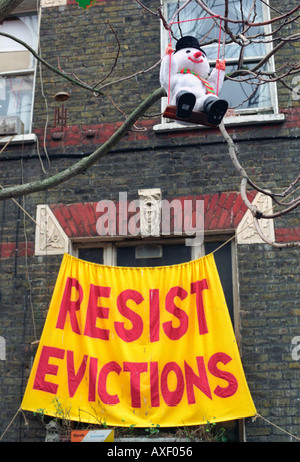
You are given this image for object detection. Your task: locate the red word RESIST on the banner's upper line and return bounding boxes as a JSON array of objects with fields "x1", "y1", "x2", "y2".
[{"x1": 56, "y1": 277, "x2": 208, "y2": 342}]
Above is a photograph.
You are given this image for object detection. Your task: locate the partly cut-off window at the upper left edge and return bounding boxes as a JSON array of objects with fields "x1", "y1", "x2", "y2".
[{"x1": 0, "y1": 13, "x2": 38, "y2": 133}]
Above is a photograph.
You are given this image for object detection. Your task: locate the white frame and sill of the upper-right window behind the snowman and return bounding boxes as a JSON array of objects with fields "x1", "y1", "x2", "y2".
[{"x1": 153, "y1": 0, "x2": 285, "y2": 131}]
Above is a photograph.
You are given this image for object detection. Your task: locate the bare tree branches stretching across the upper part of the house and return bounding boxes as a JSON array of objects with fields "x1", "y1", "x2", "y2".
[{"x1": 0, "y1": 0, "x2": 300, "y2": 248}]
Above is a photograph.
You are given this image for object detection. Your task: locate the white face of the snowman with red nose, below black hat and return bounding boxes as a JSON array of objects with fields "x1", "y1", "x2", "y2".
[{"x1": 173, "y1": 48, "x2": 209, "y2": 78}]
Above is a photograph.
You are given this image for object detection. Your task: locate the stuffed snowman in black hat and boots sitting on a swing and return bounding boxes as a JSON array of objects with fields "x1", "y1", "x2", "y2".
[{"x1": 160, "y1": 36, "x2": 228, "y2": 125}]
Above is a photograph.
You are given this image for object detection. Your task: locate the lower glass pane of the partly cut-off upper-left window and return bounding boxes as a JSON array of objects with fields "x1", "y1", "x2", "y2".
[{"x1": 0, "y1": 75, "x2": 33, "y2": 133}]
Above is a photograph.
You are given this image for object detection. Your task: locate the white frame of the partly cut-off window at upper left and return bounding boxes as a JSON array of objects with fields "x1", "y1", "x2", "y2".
[{"x1": 0, "y1": 5, "x2": 41, "y2": 145}]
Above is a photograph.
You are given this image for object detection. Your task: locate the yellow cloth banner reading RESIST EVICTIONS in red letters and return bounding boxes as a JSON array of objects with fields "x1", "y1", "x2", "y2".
[{"x1": 21, "y1": 254, "x2": 256, "y2": 427}]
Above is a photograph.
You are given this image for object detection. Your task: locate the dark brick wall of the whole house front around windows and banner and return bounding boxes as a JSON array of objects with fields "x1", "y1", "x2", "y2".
[{"x1": 0, "y1": 0, "x2": 300, "y2": 441}]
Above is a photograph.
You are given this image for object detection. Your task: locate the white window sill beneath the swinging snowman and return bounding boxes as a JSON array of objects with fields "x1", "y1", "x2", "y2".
[{"x1": 153, "y1": 114, "x2": 285, "y2": 132}]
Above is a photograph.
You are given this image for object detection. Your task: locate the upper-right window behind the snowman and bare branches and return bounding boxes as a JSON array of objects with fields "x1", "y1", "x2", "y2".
[{"x1": 161, "y1": 0, "x2": 278, "y2": 126}]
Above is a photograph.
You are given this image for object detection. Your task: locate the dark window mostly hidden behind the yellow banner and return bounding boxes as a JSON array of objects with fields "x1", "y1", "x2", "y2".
[{"x1": 74, "y1": 236, "x2": 241, "y2": 442}]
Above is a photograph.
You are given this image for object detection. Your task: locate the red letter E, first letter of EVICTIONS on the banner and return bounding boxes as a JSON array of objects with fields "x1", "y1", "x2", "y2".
[{"x1": 33, "y1": 346, "x2": 65, "y2": 395}]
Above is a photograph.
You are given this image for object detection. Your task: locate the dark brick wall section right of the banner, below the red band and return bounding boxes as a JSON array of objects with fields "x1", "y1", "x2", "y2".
[{"x1": 238, "y1": 245, "x2": 300, "y2": 442}]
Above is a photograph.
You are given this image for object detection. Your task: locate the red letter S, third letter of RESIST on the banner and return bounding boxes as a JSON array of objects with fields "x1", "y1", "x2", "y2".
[{"x1": 115, "y1": 289, "x2": 144, "y2": 342}]
